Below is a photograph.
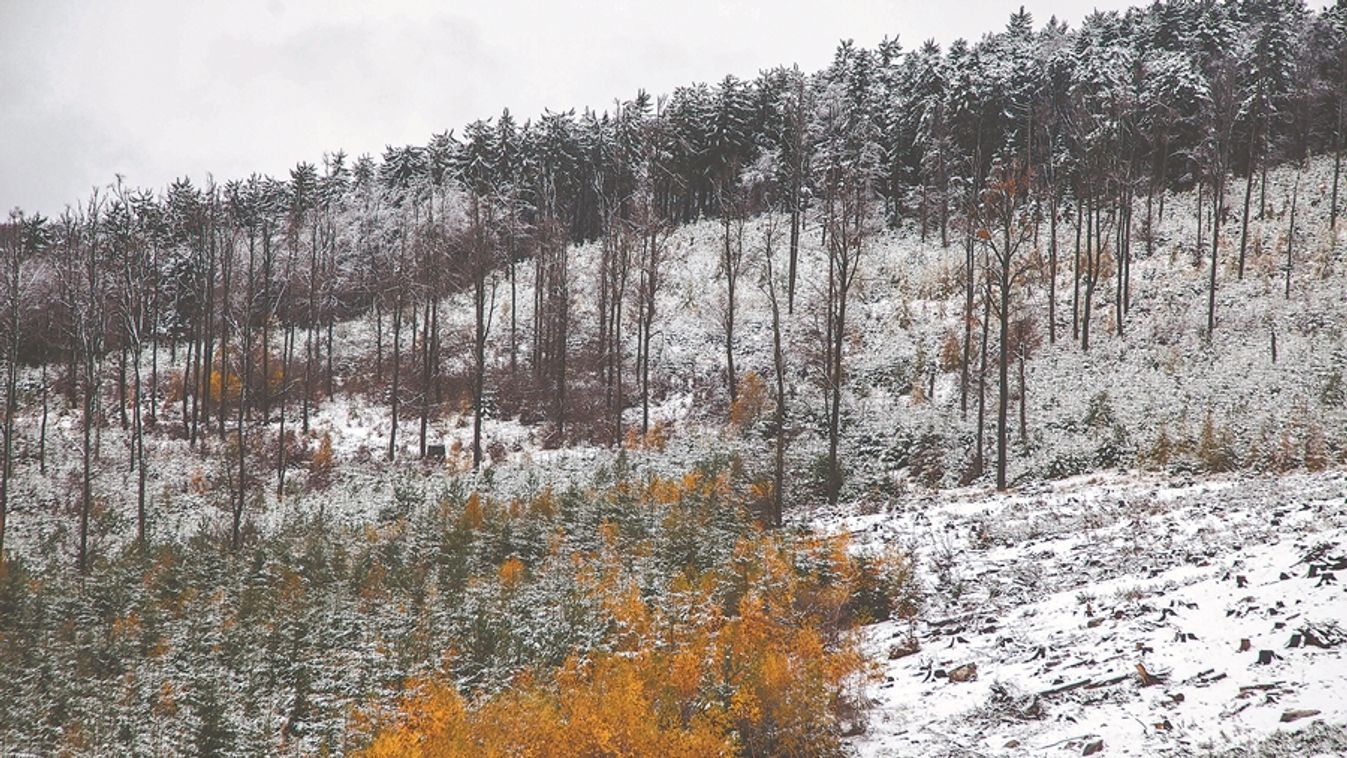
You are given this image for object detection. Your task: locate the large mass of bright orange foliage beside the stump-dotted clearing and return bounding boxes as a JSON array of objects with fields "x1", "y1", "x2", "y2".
[{"x1": 365, "y1": 527, "x2": 870, "y2": 758}]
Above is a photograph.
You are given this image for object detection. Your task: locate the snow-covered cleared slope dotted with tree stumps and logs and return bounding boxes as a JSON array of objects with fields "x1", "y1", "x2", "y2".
[{"x1": 815, "y1": 471, "x2": 1347, "y2": 755}]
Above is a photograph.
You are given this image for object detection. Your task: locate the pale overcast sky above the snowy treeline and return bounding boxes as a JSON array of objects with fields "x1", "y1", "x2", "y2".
[{"x1": 0, "y1": 0, "x2": 1129, "y2": 214}]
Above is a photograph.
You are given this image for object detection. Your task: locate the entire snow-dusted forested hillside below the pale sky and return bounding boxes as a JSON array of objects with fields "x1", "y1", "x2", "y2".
[{"x1": 0, "y1": 0, "x2": 1347, "y2": 758}]
